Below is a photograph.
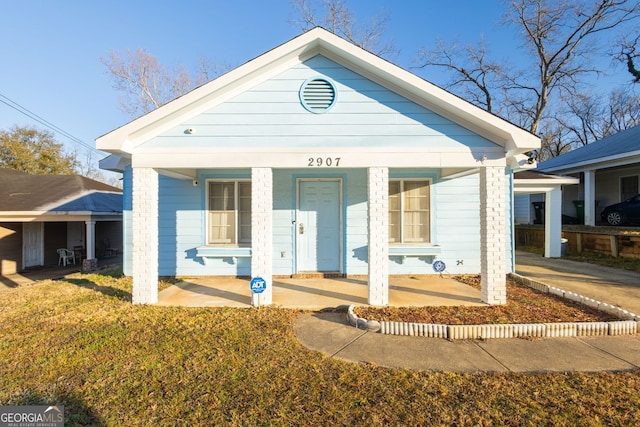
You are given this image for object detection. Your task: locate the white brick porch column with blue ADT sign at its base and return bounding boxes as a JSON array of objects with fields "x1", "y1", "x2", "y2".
[{"x1": 251, "y1": 168, "x2": 273, "y2": 306}]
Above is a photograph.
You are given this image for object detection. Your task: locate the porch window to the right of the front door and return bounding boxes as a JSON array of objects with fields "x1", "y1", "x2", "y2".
[{"x1": 389, "y1": 180, "x2": 431, "y2": 243}]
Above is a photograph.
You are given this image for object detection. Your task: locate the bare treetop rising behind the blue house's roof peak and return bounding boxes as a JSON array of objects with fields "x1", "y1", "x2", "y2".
[{"x1": 289, "y1": 0, "x2": 398, "y2": 58}]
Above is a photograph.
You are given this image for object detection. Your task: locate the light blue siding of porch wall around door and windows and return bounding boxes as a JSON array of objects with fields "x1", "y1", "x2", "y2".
[{"x1": 148, "y1": 169, "x2": 511, "y2": 276}]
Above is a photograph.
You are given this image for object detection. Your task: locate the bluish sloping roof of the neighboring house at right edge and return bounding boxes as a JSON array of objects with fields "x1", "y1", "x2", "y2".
[{"x1": 538, "y1": 125, "x2": 640, "y2": 172}]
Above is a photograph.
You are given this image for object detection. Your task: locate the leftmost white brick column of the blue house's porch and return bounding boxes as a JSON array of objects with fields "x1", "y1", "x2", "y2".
[{"x1": 131, "y1": 168, "x2": 158, "y2": 304}]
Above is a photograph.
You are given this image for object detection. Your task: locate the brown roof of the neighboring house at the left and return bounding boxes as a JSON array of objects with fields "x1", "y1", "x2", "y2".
[{"x1": 0, "y1": 168, "x2": 122, "y2": 214}]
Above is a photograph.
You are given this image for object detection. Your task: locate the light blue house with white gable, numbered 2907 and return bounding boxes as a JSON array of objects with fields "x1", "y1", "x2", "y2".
[{"x1": 97, "y1": 28, "x2": 540, "y2": 305}]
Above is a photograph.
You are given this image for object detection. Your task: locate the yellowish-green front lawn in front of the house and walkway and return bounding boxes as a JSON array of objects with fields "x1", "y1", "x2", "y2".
[{"x1": 0, "y1": 274, "x2": 640, "y2": 426}]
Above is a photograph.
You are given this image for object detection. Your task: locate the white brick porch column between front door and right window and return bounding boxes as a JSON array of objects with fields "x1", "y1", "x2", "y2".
[{"x1": 367, "y1": 168, "x2": 389, "y2": 305}]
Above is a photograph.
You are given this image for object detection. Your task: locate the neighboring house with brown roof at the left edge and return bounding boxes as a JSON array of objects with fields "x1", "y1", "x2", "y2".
[{"x1": 0, "y1": 168, "x2": 122, "y2": 275}]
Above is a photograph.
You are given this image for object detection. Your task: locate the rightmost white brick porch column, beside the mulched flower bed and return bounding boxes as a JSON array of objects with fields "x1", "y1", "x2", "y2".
[{"x1": 480, "y1": 166, "x2": 507, "y2": 304}]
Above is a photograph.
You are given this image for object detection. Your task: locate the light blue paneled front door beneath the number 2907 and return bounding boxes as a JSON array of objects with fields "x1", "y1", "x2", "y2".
[{"x1": 296, "y1": 180, "x2": 342, "y2": 272}]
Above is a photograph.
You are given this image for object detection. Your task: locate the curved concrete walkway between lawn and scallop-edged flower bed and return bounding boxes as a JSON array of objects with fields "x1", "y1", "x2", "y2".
[{"x1": 295, "y1": 312, "x2": 640, "y2": 372}]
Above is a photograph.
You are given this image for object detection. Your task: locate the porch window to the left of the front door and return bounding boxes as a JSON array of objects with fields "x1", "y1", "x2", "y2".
[{"x1": 207, "y1": 181, "x2": 251, "y2": 244}]
